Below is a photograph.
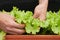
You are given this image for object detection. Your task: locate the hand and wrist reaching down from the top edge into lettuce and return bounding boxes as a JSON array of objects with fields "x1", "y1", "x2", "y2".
[{"x1": 33, "y1": 0, "x2": 48, "y2": 21}]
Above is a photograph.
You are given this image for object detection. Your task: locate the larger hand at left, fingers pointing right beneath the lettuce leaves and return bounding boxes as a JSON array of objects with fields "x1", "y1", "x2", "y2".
[{"x1": 0, "y1": 13, "x2": 25, "y2": 34}]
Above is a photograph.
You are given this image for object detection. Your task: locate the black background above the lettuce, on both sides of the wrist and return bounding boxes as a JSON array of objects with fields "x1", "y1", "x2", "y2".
[{"x1": 0, "y1": 0, "x2": 60, "y2": 11}]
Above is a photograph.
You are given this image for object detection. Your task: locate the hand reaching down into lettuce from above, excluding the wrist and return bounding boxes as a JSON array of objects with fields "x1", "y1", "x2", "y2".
[{"x1": 33, "y1": 4, "x2": 47, "y2": 21}]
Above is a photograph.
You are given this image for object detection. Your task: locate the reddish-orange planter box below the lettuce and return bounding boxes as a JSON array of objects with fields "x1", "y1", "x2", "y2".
[{"x1": 5, "y1": 35, "x2": 60, "y2": 40}]
